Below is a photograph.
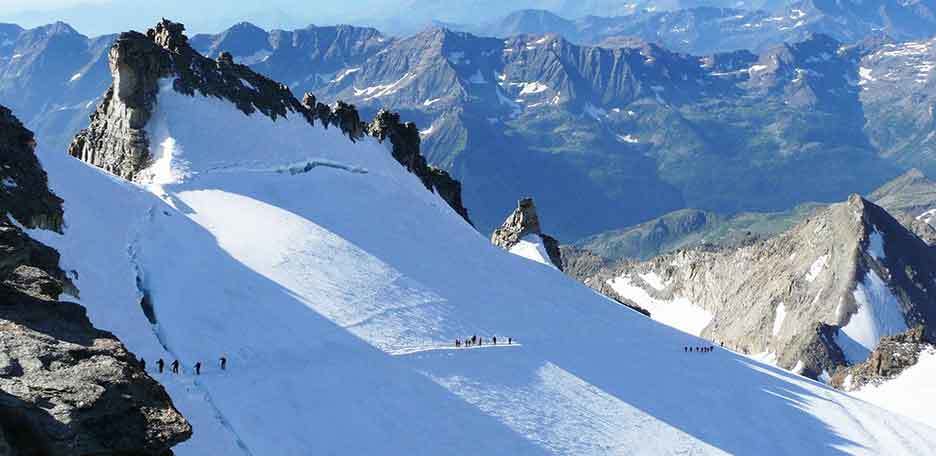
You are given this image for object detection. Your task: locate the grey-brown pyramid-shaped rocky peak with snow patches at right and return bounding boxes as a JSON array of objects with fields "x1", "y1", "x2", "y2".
[{"x1": 586, "y1": 195, "x2": 936, "y2": 378}]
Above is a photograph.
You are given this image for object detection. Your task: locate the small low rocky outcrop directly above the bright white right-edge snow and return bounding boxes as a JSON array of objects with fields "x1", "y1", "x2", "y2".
[{"x1": 831, "y1": 326, "x2": 936, "y2": 391}]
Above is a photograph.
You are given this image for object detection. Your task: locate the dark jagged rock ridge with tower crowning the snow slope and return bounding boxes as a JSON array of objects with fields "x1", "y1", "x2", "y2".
[{"x1": 69, "y1": 19, "x2": 470, "y2": 223}]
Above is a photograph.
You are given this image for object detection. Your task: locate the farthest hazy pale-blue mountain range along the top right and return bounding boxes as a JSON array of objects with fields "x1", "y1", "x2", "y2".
[{"x1": 462, "y1": 0, "x2": 936, "y2": 54}]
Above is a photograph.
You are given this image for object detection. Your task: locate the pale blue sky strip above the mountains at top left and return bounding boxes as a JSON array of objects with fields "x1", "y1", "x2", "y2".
[{"x1": 0, "y1": 0, "x2": 628, "y2": 36}]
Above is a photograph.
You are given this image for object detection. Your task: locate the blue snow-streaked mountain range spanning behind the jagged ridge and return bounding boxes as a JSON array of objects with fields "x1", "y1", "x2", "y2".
[{"x1": 0, "y1": 4, "x2": 936, "y2": 242}]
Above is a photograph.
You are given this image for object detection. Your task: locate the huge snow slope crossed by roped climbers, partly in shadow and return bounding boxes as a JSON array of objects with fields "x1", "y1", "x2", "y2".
[{"x1": 27, "y1": 83, "x2": 936, "y2": 456}]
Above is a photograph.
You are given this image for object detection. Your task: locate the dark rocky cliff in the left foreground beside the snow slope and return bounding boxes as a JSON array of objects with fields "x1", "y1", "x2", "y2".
[{"x1": 0, "y1": 107, "x2": 192, "y2": 456}]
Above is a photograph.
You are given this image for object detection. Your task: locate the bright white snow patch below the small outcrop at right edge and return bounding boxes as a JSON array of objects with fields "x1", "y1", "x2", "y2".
[{"x1": 851, "y1": 350, "x2": 936, "y2": 427}]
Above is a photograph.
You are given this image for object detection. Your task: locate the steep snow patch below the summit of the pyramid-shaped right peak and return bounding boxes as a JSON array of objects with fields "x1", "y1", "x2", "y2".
[{"x1": 838, "y1": 271, "x2": 908, "y2": 363}]
